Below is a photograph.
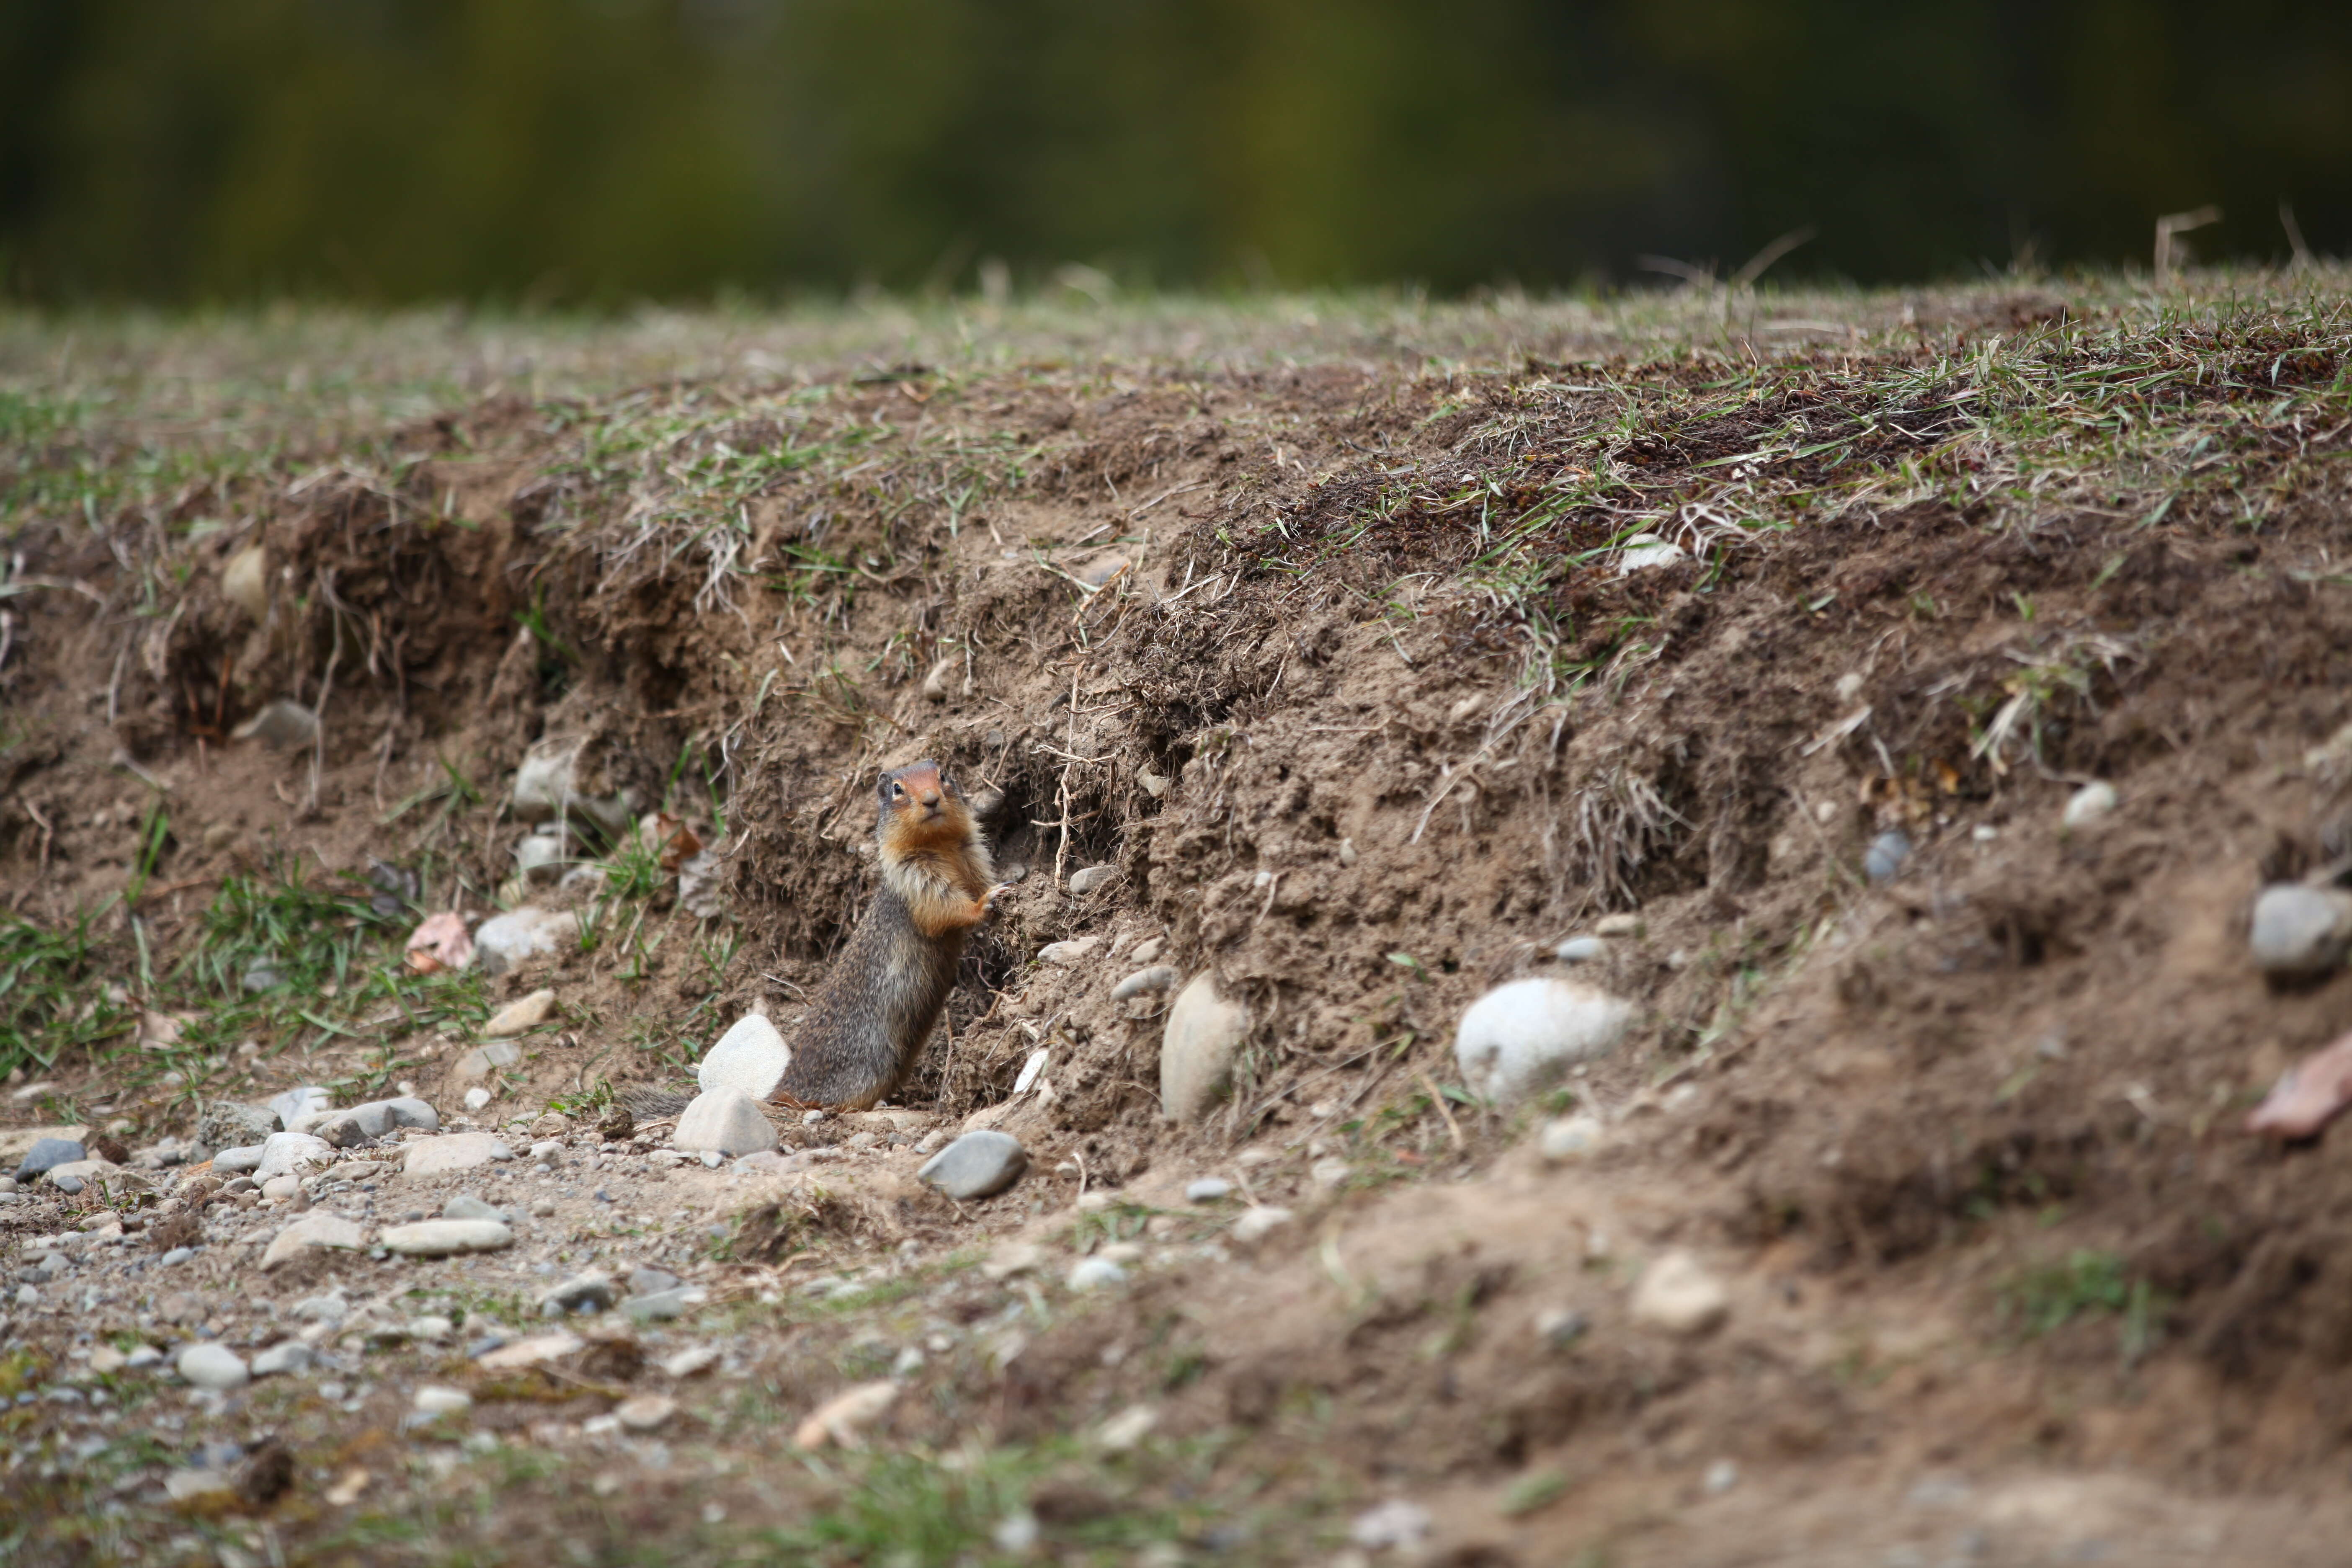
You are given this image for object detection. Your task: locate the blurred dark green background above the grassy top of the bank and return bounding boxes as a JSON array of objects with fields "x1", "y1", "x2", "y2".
[{"x1": 0, "y1": 0, "x2": 2352, "y2": 306}]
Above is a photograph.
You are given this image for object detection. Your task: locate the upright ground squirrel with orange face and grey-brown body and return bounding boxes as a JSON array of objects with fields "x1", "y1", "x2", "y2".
[{"x1": 774, "y1": 762, "x2": 997, "y2": 1109}]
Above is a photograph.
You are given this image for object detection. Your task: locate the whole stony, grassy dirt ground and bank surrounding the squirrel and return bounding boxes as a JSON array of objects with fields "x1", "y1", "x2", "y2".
[{"x1": 13, "y1": 271, "x2": 2352, "y2": 1568}]
